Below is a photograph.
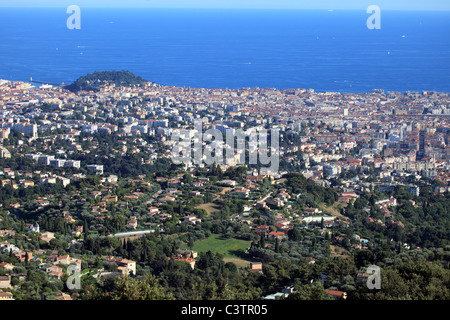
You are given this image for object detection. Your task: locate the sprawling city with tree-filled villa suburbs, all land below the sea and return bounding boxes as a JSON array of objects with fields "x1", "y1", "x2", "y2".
[{"x1": 0, "y1": 72, "x2": 450, "y2": 300}]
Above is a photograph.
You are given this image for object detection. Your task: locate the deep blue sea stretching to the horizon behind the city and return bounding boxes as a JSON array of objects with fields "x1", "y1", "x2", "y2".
[{"x1": 0, "y1": 8, "x2": 450, "y2": 92}]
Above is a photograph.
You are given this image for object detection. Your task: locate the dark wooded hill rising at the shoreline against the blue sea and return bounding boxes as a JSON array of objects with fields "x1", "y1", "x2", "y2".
[{"x1": 65, "y1": 71, "x2": 148, "y2": 92}]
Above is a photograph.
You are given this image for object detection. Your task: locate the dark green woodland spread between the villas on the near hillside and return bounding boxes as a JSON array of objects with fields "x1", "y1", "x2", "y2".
[{"x1": 0, "y1": 152, "x2": 450, "y2": 299}]
